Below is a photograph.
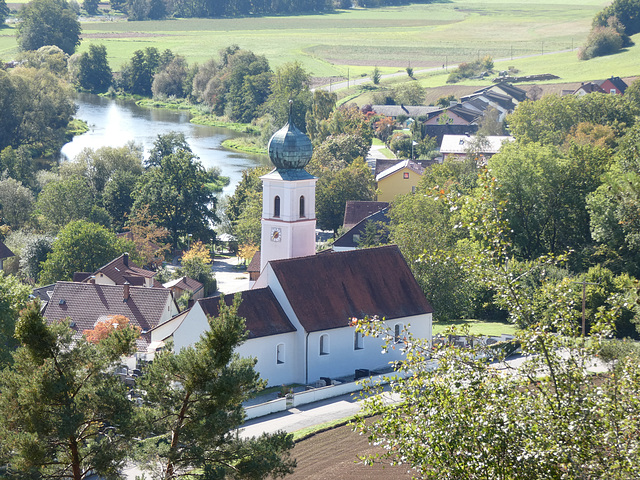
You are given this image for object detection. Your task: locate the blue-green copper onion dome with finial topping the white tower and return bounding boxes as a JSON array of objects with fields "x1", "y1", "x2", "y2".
[{"x1": 268, "y1": 101, "x2": 313, "y2": 170}]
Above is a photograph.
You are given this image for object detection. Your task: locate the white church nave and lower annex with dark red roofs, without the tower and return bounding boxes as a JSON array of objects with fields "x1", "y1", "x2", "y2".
[{"x1": 173, "y1": 245, "x2": 433, "y2": 385}]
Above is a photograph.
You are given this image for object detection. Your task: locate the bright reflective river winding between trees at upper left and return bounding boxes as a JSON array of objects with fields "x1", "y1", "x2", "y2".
[{"x1": 61, "y1": 94, "x2": 269, "y2": 195}]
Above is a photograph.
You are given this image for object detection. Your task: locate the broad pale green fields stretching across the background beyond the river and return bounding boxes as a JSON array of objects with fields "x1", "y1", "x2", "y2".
[{"x1": 0, "y1": 0, "x2": 640, "y2": 87}]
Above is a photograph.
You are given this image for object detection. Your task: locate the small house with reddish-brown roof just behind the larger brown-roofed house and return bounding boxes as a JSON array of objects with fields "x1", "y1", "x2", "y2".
[{"x1": 73, "y1": 253, "x2": 162, "y2": 288}]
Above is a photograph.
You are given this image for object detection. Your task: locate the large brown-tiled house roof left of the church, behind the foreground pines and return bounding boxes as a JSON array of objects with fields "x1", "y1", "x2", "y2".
[{"x1": 43, "y1": 282, "x2": 179, "y2": 355}]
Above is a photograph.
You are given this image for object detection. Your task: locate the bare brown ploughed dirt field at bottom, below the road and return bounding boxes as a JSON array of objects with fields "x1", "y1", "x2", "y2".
[{"x1": 286, "y1": 425, "x2": 411, "y2": 480}]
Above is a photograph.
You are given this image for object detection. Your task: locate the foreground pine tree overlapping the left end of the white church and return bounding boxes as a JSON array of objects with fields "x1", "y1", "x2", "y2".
[{"x1": 140, "y1": 295, "x2": 295, "y2": 480}]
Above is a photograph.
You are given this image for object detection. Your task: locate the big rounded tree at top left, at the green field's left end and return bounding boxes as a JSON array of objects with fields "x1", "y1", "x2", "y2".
[{"x1": 16, "y1": 0, "x2": 82, "y2": 55}]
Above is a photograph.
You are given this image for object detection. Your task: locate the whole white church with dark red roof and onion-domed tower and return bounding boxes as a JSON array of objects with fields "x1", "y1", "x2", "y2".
[{"x1": 162, "y1": 109, "x2": 433, "y2": 385}]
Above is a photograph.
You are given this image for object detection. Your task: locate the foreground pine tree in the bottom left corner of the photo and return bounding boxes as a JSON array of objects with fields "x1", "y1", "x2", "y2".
[{"x1": 0, "y1": 302, "x2": 138, "y2": 480}]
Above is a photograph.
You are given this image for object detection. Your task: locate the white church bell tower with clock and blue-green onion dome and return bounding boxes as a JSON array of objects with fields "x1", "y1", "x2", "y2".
[{"x1": 260, "y1": 102, "x2": 317, "y2": 272}]
